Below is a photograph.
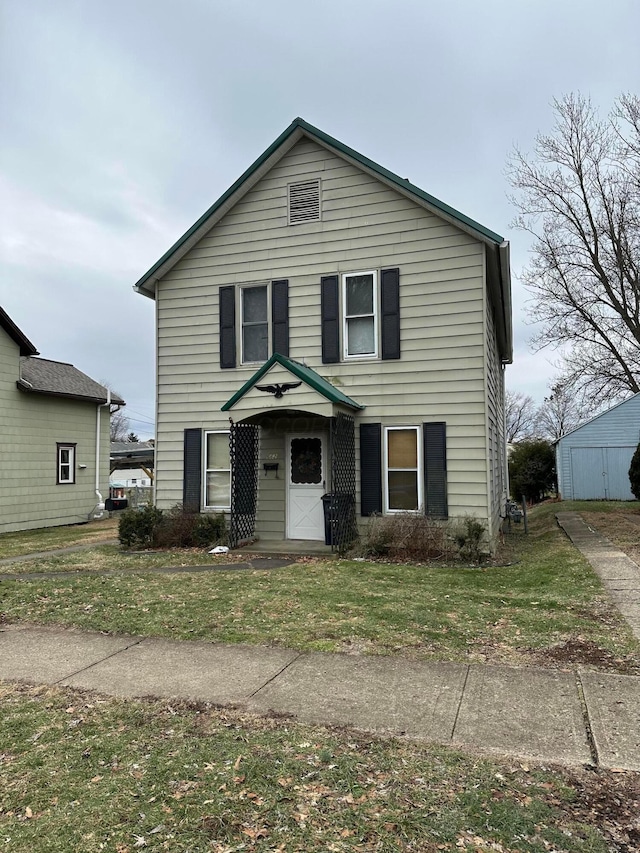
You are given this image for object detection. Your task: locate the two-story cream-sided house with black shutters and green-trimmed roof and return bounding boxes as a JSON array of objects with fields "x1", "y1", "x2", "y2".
[{"x1": 136, "y1": 119, "x2": 512, "y2": 543}]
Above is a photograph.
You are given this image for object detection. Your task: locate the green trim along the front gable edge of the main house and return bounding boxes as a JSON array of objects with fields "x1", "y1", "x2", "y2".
[{"x1": 134, "y1": 118, "x2": 504, "y2": 295}]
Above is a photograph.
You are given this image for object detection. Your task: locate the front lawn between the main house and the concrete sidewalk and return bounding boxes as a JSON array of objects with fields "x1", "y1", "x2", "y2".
[{"x1": 0, "y1": 504, "x2": 640, "y2": 673}]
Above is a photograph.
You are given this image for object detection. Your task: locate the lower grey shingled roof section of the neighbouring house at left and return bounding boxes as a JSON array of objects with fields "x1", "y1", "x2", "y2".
[{"x1": 16, "y1": 358, "x2": 124, "y2": 405}]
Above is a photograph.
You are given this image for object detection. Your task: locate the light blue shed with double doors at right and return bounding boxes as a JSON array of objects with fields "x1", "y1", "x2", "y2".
[{"x1": 556, "y1": 394, "x2": 640, "y2": 501}]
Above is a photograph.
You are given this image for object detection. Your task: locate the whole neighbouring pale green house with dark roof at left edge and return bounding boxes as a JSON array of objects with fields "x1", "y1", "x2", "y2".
[{"x1": 0, "y1": 308, "x2": 124, "y2": 533}]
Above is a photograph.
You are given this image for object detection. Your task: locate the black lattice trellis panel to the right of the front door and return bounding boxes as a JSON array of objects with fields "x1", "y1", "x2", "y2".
[{"x1": 328, "y1": 413, "x2": 358, "y2": 551}]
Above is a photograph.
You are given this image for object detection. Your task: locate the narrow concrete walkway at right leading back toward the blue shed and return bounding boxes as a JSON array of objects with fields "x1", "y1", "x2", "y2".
[{"x1": 556, "y1": 512, "x2": 640, "y2": 640}]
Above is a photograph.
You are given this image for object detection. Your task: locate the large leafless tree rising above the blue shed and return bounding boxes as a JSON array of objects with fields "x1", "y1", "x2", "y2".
[{"x1": 508, "y1": 95, "x2": 640, "y2": 407}]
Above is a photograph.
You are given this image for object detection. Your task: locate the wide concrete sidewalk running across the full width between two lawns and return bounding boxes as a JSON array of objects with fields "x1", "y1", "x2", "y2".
[{"x1": 0, "y1": 625, "x2": 640, "y2": 771}]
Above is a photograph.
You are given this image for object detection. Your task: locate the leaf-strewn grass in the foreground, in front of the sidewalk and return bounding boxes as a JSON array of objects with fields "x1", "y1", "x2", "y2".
[{"x1": 0, "y1": 685, "x2": 640, "y2": 853}]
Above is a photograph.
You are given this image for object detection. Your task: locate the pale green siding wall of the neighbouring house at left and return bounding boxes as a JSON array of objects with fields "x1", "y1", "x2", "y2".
[{"x1": 0, "y1": 330, "x2": 109, "y2": 533}]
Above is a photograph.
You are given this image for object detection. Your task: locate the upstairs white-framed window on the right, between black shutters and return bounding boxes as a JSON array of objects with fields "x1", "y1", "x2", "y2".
[{"x1": 342, "y1": 272, "x2": 378, "y2": 358}]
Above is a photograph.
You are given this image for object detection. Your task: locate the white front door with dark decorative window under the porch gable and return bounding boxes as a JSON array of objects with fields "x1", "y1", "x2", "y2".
[{"x1": 287, "y1": 433, "x2": 327, "y2": 540}]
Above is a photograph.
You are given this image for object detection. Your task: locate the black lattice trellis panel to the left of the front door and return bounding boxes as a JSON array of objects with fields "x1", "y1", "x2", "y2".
[{"x1": 229, "y1": 423, "x2": 260, "y2": 548}]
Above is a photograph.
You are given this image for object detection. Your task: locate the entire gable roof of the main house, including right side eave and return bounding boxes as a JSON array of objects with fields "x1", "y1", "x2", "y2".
[{"x1": 134, "y1": 118, "x2": 513, "y2": 363}]
